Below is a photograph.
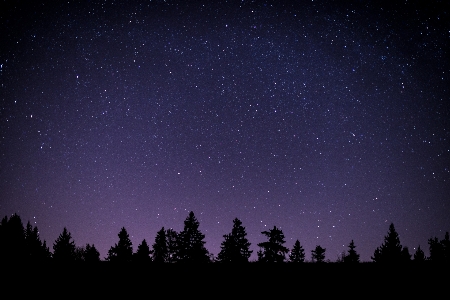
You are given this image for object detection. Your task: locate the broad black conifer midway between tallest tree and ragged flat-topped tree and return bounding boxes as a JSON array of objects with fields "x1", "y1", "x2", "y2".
[{"x1": 217, "y1": 218, "x2": 253, "y2": 263}]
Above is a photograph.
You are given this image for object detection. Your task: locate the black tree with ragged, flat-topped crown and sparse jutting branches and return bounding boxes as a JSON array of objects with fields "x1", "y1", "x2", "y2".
[{"x1": 258, "y1": 226, "x2": 289, "y2": 263}]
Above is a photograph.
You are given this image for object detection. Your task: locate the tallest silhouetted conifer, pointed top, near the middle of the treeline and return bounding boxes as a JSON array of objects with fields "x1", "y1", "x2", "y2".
[{"x1": 176, "y1": 211, "x2": 209, "y2": 263}]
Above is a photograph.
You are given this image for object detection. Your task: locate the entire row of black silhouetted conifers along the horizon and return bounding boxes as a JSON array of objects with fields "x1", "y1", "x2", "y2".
[{"x1": 0, "y1": 212, "x2": 450, "y2": 264}]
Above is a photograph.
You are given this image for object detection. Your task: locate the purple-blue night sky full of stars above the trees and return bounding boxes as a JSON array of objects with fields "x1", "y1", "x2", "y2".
[{"x1": 0, "y1": 0, "x2": 450, "y2": 261}]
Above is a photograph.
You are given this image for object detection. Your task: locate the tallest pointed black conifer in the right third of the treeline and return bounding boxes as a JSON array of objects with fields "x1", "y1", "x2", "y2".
[{"x1": 371, "y1": 223, "x2": 403, "y2": 263}]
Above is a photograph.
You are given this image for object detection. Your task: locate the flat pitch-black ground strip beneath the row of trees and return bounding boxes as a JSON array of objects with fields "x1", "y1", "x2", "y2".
[{"x1": 5, "y1": 262, "x2": 450, "y2": 299}]
